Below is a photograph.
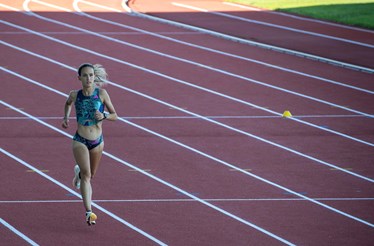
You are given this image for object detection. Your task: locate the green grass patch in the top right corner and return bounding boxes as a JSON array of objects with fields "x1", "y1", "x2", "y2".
[{"x1": 226, "y1": 0, "x2": 374, "y2": 29}]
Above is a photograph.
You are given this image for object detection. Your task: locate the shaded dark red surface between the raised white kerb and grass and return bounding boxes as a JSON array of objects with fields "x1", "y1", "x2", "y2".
[{"x1": 129, "y1": 0, "x2": 374, "y2": 73}]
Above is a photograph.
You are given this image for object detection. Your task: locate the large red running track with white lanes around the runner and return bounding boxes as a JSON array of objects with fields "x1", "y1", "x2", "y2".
[{"x1": 0, "y1": 0, "x2": 374, "y2": 245}]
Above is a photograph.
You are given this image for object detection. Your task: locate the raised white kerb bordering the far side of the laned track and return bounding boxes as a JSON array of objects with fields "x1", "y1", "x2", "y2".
[{"x1": 74, "y1": 0, "x2": 374, "y2": 94}]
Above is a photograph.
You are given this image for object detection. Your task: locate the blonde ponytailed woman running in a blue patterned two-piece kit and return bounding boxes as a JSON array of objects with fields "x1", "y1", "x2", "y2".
[{"x1": 62, "y1": 63, "x2": 117, "y2": 225}]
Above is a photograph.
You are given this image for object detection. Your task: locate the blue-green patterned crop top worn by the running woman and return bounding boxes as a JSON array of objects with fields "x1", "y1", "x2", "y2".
[{"x1": 75, "y1": 88, "x2": 104, "y2": 126}]
